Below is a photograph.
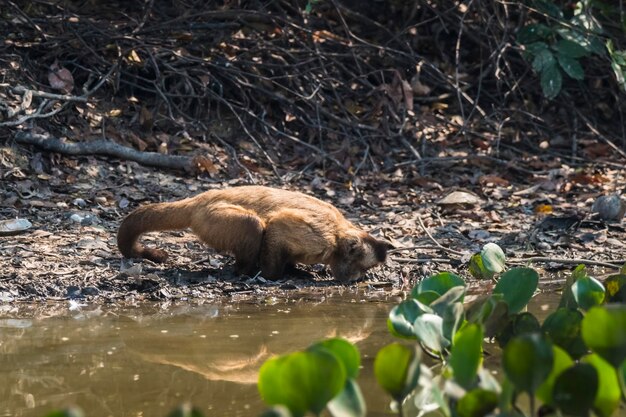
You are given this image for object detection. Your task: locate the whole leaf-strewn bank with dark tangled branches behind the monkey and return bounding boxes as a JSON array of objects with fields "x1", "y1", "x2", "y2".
[{"x1": 0, "y1": 0, "x2": 626, "y2": 302}]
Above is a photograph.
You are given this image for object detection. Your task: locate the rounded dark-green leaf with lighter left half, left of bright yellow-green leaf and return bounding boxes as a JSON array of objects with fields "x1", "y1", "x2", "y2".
[{"x1": 502, "y1": 333, "x2": 554, "y2": 394}]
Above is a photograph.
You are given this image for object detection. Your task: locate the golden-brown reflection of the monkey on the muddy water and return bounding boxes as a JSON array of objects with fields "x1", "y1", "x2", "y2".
[{"x1": 125, "y1": 304, "x2": 387, "y2": 384}]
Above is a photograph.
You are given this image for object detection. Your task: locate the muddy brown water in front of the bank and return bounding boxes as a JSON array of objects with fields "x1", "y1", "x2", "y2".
[{"x1": 0, "y1": 290, "x2": 555, "y2": 417}]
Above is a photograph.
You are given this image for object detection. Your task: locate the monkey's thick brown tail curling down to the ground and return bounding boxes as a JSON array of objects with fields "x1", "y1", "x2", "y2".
[{"x1": 117, "y1": 199, "x2": 193, "y2": 262}]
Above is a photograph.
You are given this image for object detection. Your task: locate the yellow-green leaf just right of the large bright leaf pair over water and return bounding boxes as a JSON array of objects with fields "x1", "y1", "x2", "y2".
[{"x1": 374, "y1": 343, "x2": 420, "y2": 402}]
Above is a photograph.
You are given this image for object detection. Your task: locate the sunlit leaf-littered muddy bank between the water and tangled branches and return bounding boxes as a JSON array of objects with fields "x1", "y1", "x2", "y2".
[{"x1": 0, "y1": 148, "x2": 626, "y2": 302}]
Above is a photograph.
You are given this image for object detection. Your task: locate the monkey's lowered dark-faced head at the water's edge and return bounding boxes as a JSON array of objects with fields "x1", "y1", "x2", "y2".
[{"x1": 330, "y1": 231, "x2": 393, "y2": 281}]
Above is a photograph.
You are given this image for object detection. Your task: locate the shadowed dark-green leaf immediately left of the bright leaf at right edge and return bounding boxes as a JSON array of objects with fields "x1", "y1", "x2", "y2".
[{"x1": 541, "y1": 308, "x2": 588, "y2": 359}]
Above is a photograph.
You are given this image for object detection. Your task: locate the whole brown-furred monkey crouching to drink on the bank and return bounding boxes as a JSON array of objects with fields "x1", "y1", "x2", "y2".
[{"x1": 117, "y1": 186, "x2": 390, "y2": 281}]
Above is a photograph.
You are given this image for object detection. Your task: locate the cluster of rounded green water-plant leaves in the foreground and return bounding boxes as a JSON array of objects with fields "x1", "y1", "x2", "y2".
[{"x1": 47, "y1": 240, "x2": 626, "y2": 417}]
